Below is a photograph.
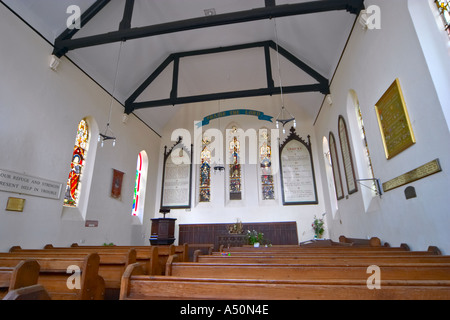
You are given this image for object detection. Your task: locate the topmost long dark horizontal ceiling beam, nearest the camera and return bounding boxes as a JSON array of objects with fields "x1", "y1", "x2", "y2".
[{"x1": 54, "y1": 0, "x2": 364, "y2": 56}]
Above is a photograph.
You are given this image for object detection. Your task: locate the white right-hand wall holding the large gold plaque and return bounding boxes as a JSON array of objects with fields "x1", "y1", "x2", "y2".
[{"x1": 316, "y1": 0, "x2": 450, "y2": 252}]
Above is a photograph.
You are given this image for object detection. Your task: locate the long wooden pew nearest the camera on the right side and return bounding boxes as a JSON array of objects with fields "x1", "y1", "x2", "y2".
[{"x1": 120, "y1": 264, "x2": 450, "y2": 300}]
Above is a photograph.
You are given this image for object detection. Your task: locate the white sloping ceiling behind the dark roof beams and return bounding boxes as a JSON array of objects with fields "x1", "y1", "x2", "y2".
[{"x1": 3, "y1": 0, "x2": 356, "y2": 134}]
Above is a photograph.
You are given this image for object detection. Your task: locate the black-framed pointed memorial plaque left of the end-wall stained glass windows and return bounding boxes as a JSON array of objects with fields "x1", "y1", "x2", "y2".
[{"x1": 161, "y1": 137, "x2": 193, "y2": 209}]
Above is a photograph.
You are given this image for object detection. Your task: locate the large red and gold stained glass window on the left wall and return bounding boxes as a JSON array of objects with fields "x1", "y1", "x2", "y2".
[{"x1": 64, "y1": 120, "x2": 90, "y2": 207}]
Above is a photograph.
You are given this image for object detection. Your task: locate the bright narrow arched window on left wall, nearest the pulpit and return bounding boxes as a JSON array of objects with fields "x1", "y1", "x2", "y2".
[{"x1": 132, "y1": 151, "x2": 148, "y2": 222}]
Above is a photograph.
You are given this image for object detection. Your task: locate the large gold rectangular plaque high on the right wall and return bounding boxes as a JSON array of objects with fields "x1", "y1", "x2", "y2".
[{"x1": 375, "y1": 79, "x2": 416, "y2": 159}]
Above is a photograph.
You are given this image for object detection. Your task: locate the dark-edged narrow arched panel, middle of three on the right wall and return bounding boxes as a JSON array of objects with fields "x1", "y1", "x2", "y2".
[{"x1": 338, "y1": 116, "x2": 358, "y2": 194}]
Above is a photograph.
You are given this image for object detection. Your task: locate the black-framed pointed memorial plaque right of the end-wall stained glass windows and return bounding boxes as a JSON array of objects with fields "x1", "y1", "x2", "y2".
[{"x1": 280, "y1": 128, "x2": 318, "y2": 205}]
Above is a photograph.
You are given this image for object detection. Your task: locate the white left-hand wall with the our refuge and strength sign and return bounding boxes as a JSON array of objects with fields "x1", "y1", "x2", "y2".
[{"x1": 0, "y1": 5, "x2": 160, "y2": 251}]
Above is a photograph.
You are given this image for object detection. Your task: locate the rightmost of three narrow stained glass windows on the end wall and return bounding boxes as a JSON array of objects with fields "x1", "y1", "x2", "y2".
[{"x1": 259, "y1": 129, "x2": 275, "y2": 200}]
